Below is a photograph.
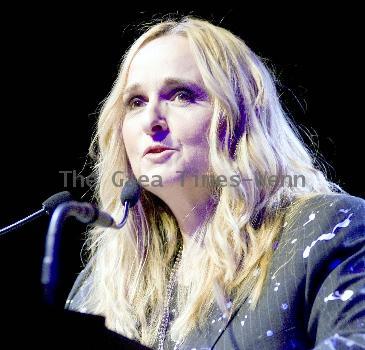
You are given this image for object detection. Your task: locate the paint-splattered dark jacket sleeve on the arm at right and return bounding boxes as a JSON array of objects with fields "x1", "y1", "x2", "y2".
[{"x1": 303, "y1": 195, "x2": 365, "y2": 350}]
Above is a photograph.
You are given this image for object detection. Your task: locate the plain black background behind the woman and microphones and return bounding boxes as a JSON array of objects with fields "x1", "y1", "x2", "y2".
[{"x1": 0, "y1": 4, "x2": 365, "y2": 332}]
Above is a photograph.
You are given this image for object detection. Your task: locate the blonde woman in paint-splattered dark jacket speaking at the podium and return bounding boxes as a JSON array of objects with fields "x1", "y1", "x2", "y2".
[{"x1": 67, "y1": 17, "x2": 365, "y2": 349}]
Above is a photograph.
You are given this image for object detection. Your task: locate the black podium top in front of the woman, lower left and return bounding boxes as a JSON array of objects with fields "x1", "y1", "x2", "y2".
[{"x1": 0, "y1": 305, "x2": 150, "y2": 350}]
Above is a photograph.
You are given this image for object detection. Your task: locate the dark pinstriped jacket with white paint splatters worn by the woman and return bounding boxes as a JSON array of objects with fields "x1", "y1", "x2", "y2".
[{"x1": 67, "y1": 194, "x2": 365, "y2": 350}]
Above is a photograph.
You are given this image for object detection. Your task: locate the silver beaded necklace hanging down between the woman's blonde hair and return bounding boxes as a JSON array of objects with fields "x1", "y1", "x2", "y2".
[{"x1": 158, "y1": 245, "x2": 183, "y2": 350}]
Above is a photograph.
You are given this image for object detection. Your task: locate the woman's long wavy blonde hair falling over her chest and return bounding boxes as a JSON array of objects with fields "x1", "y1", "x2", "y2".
[{"x1": 80, "y1": 17, "x2": 341, "y2": 346}]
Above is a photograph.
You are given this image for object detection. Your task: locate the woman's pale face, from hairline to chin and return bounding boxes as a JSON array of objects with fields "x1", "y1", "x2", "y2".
[{"x1": 122, "y1": 35, "x2": 212, "y2": 194}]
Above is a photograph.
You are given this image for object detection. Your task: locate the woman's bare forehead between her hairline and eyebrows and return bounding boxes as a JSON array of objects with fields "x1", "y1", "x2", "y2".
[{"x1": 127, "y1": 35, "x2": 201, "y2": 85}]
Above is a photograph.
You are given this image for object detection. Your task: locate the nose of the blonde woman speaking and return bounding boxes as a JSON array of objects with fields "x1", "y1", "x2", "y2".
[{"x1": 143, "y1": 101, "x2": 169, "y2": 139}]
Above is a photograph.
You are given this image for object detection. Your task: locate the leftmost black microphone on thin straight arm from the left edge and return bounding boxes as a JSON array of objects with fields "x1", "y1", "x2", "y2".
[{"x1": 0, "y1": 191, "x2": 72, "y2": 236}]
